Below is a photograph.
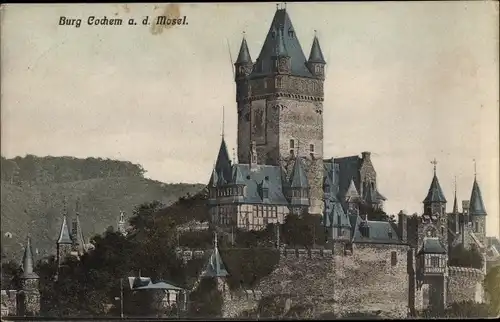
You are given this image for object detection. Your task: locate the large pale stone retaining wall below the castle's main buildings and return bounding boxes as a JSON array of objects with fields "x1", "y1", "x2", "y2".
[{"x1": 219, "y1": 244, "x2": 409, "y2": 318}]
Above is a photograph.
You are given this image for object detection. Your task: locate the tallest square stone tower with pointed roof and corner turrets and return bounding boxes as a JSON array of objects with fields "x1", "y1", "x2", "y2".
[{"x1": 235, "y1": 9, "x2": 326, "y2": 214}]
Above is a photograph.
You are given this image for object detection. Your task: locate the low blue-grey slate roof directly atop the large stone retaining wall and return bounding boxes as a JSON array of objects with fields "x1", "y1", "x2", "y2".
[{"x1": 353, "y1": 220, "x2": 401, "y2": 244}]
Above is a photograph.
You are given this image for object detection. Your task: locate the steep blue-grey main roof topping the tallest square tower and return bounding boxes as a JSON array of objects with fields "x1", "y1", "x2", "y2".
[{"x1": 251, "y1": 9, "x2": 312, "y2": 77}]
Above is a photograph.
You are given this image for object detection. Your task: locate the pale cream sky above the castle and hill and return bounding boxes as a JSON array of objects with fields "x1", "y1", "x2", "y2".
[{"x1": 0, "y1": 1, "x2": 500, "y2": 236}]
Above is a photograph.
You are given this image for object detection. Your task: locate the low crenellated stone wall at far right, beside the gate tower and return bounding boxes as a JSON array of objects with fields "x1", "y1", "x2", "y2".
[{"x1": 447, "y1": 266, "x2": 484, "y2": 304}]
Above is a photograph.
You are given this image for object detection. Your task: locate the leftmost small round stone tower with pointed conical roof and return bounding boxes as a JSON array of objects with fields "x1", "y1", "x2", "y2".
[{"x1": 18, "y1": 238, "x2": 40, "y2": 316}]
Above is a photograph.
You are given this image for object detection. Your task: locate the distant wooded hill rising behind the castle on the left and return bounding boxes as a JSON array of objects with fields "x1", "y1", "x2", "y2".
[{"x1": 1, "y1": 156, "x2": 204, "y2": 260}]
